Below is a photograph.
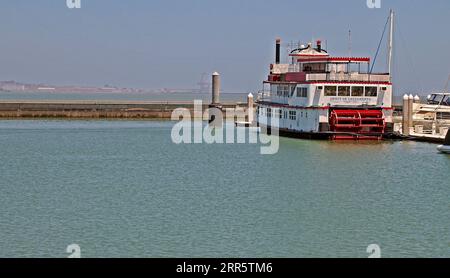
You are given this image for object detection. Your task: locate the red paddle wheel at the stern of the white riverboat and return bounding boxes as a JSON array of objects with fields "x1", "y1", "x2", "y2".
[{"x1": 330, "y1": 110, "x2": 386, "y2": 140}]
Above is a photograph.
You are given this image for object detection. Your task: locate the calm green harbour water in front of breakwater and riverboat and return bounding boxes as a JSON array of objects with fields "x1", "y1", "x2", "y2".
[{"x1": 0, "y1": 120, "x2": 450, "y2": 257}]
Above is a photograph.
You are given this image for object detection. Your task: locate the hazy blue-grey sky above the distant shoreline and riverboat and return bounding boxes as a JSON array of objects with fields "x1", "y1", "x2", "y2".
[{"x1": 0, "y1": 0, "x2": 450, "y2": 94}]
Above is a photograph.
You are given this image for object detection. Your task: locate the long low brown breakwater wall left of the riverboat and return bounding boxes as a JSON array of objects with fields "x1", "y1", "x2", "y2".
[{"x1": 0, "y1": 100, "x2": 247, "y2": 119}]
